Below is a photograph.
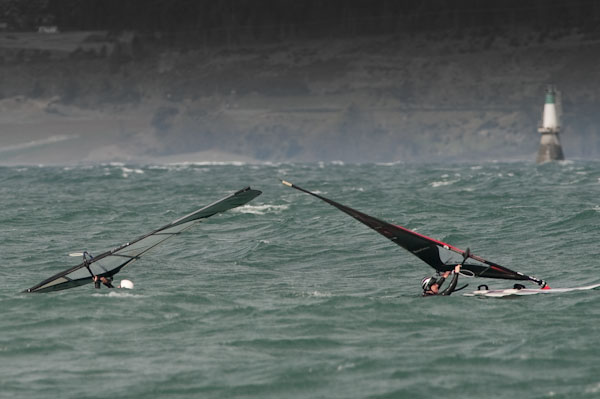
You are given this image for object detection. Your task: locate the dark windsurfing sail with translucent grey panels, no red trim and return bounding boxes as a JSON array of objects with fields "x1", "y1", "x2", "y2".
[{"x1": 23, "y1": 187, "x2": 261, "y2": 292}]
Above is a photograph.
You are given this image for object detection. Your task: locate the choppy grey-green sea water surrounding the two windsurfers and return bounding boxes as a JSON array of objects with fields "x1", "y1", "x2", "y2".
[{"x1": 0, "y1": 161, "x2": 600, "y2": 399}]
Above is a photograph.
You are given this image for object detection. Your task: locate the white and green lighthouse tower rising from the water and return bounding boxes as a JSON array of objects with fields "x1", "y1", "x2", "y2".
[{"x1": 535, "y1": 86, "x2": 565, "y2": 163}]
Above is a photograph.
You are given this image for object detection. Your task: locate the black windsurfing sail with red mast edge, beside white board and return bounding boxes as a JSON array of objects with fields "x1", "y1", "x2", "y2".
[{"x1": 282, "y1": 180, "x2": 546, "y2": 286}]
